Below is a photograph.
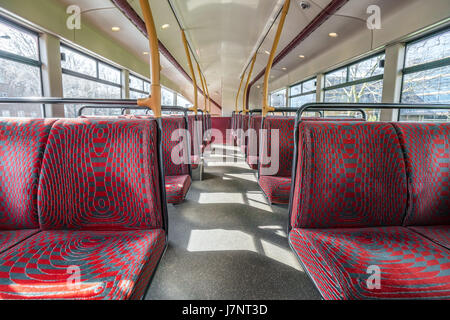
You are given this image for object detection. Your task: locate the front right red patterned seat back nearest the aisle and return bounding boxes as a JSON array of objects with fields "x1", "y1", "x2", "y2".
[{"x1": 290, "y1": 121, "x2": 407, "y2": 228}]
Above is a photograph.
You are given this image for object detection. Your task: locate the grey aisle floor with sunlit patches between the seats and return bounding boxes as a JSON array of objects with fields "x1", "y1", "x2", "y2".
[{"x1": 147, "y1": 146, "x2": 320, "y2": 300}]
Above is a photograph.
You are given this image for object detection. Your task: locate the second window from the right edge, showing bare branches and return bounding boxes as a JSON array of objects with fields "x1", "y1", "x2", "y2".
[{"x1": 324, "y1": 53, "x2": 385, "y2": 121}]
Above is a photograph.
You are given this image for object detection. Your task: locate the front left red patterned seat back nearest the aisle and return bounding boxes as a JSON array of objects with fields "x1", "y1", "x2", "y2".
[{"x1": 38, "y1": 119, "x2": 165, "y2": 231}]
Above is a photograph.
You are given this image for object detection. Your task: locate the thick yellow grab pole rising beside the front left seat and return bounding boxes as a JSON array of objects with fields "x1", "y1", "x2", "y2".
[{"x1": 138, "y1": 0, "x2": 161, "y2": 118}]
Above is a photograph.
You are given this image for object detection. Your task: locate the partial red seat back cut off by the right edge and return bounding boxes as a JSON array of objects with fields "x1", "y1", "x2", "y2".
[{"x1": 394, "y1": 123, "x2": 450, "y2": 226}]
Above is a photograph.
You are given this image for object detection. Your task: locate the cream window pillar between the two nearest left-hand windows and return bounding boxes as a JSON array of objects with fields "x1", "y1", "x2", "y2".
[{"x1": 39, "y1": 34, "x2": 65, "y2": 118}]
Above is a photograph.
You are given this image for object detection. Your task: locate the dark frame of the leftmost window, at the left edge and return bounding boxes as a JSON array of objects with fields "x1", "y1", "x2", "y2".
[{"x1": 0, "y1": 15, "x2": 47, "y2": 118}]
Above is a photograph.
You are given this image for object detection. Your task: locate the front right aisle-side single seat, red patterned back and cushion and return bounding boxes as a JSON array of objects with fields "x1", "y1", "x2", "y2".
[{"x1": 289, "y1": 121, "x2": 450, "y2": 299}]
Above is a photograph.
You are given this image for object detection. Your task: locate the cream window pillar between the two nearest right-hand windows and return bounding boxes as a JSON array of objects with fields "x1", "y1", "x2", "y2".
[{"x1": 380, "y1": 43, "x2": 405, "y2": 121}]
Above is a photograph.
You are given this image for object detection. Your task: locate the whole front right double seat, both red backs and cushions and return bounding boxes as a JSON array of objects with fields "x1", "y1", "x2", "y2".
[{"x1": 289, "y1": 121, "x2": 450, "y2": 300}]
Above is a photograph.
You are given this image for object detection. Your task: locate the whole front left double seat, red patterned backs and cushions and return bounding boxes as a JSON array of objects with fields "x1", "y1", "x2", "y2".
[{"x1": 0, "y1": 119, "x2": 167, "y2": 299}]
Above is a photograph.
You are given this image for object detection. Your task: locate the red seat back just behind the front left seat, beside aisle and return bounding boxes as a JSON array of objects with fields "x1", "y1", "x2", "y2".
[{"x1": 162, "y1": 116, "x2": 189, "y2": 176}]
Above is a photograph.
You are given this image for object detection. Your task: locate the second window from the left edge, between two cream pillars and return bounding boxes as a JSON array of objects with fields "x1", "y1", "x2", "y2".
[{"x1": 61, "y1": 46, "x2": 122, "y2": 118}]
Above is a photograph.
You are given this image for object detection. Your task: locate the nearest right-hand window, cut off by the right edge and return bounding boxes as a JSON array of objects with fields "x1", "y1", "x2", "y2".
[{"x1": 400, "y1": 29, "x2": 450, "y2": 121}]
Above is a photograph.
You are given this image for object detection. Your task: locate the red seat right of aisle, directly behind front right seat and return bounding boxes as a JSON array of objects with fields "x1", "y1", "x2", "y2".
[{"x1": 259, "y1": 116, "x2": 295, "y2": 204}]
